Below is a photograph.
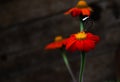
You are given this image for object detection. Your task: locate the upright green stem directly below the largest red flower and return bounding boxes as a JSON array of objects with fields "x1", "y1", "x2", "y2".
[{"x1": 79, "y1": 52, "x2": 85, "y2": 82}]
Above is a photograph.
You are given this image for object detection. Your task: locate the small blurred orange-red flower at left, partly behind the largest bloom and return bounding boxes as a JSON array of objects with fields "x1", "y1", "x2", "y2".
[{"x1": 45, "y1": 36, "x2": 65, "y2": 50}]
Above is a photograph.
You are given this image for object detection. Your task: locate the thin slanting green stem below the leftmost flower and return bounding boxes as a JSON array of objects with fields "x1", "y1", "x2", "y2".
[{"x1": 62, "y1": 52, "x2": 77, "y2": 82}]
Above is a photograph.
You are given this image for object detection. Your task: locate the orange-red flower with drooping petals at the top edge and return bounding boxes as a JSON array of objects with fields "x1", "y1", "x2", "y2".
[{"x1": 65, "y1": 0, "x2": 92, "y2": 17}]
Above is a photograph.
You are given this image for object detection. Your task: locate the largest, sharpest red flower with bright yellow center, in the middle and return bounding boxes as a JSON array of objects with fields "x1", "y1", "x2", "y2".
[{"x1": 64, "y1": 32, "x2": 99, "y2": 52}]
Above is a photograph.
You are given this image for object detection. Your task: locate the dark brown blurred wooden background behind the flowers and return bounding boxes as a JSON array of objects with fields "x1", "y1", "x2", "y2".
[{"x1": 0, "y1": 0, "x2": 120, "y2": 82}]
